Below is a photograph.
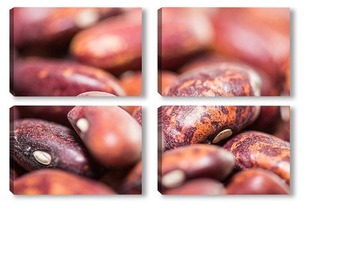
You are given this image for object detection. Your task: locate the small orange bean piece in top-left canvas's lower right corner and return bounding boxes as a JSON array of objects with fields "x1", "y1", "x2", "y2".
[{"x1": 120, "y1": 72, "x2": 142, "y2": 96}]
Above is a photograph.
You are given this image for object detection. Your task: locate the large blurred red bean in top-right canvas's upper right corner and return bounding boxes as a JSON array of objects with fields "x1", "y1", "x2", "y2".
[{"x1": 213, "y1": 8, "x2": 290, "y2": 81}]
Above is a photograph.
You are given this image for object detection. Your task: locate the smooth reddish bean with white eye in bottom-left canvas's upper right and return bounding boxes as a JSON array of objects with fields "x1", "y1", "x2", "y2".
[{"x1": 67, "y1": 106, "x2": 142, "y2": 168}]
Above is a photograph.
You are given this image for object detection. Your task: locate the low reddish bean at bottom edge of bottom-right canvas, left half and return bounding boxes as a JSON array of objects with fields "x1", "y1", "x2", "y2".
[{"x1": 162, "y1": 178, "x2": 225, "y2": 195}]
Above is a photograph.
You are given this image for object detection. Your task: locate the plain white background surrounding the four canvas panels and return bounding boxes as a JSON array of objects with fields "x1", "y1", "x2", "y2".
[{"x1": 0, "y1": 0, "x2": 350, "y2": 255}]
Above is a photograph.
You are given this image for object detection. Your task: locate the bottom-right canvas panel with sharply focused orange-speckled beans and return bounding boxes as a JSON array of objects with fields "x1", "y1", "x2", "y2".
[{"x1": 158, "y1": 105, "x2": 291, "y2": 195}]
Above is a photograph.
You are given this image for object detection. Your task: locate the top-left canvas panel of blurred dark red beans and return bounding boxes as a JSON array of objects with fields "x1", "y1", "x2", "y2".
[{"x1": 10, "y1": 8, "x2": 142, "y2": 96}]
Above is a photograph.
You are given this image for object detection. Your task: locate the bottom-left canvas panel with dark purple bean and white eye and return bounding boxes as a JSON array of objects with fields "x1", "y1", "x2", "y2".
[{"x1": 10, "y1": 106, "x2": 142, "y2": 195}]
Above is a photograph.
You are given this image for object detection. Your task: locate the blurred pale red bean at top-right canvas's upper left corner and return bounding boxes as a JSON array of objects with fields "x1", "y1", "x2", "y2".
[{"x1": 158, "y1": 8, "x2": 213, "y2": 69}]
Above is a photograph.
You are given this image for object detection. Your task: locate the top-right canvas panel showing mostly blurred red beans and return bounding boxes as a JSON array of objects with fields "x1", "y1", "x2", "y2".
[{"x1": 158, "y1": 8, "x2": 291, "y2": 97}]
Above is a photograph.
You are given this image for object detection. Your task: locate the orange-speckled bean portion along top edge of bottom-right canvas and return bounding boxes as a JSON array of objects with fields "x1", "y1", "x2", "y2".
[{"x1": 158, "y1": 106, "x2": 260, "y2": 151}]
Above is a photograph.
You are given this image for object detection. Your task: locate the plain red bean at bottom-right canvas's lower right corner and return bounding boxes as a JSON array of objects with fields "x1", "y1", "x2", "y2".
[{"x1": 226, "y1": 168, "x2": 289, "y2": 195}]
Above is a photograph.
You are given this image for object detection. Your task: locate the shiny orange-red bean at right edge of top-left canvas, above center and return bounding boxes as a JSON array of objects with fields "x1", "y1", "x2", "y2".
[{"x1": 70, "y1": 8, "x2": 142, "y2": 74}]
